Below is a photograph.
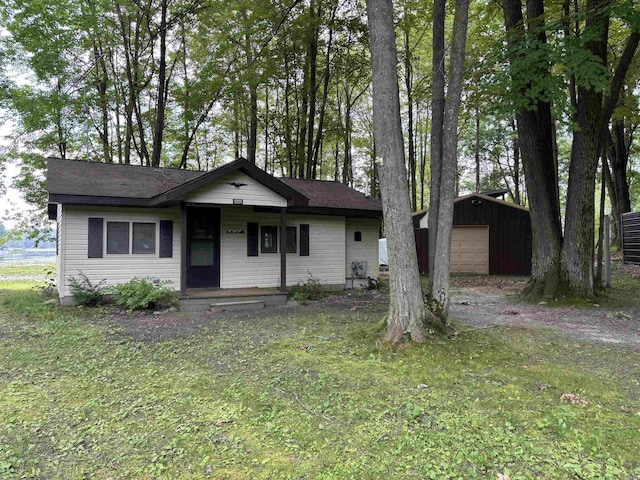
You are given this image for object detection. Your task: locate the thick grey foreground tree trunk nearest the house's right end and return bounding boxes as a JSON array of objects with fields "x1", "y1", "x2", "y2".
[{"x1": 367, "y1": 0, "x2": 442, "y2": 343}]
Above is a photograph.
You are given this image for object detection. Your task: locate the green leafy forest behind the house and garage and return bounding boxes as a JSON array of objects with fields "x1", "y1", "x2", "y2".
[{"x1": 0, "y1": 0, "x2": 640, "y2": 240}]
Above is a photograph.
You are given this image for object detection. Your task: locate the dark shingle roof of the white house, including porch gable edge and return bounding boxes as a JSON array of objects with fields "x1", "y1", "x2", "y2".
[{"x1": 47, "y1": 158, "x2": 382, "y2": 213}]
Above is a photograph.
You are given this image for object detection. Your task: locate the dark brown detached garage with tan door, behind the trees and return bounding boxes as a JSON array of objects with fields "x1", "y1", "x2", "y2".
[{"x1": 413, "y1": 190, "x2": 532, "y2": 275}]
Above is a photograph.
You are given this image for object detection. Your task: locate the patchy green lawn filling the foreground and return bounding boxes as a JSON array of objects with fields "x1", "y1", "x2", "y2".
[{"x1": 0, "y1": 264, "x2": 640, "y2": 479}]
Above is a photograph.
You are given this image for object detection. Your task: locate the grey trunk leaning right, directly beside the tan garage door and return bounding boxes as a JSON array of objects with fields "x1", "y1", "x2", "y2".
[{"x1": 431, "y1": 0, "x2": 469, "y2": 319}]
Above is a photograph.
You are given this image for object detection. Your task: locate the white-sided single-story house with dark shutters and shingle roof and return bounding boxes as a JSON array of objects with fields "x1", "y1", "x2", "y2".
[{"x1": 47, "y1": 158, "x2": 382, "y2": 304}]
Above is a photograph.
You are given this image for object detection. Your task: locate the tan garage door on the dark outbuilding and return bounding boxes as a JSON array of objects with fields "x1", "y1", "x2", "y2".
[{"x1": 451, "y1": 225, "x2": 489, "y2": 274}]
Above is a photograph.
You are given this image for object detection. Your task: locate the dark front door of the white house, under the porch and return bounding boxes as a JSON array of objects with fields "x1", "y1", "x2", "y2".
[{"x1": 187, "y1": 207, "x2": 220, "y2": 288}]
